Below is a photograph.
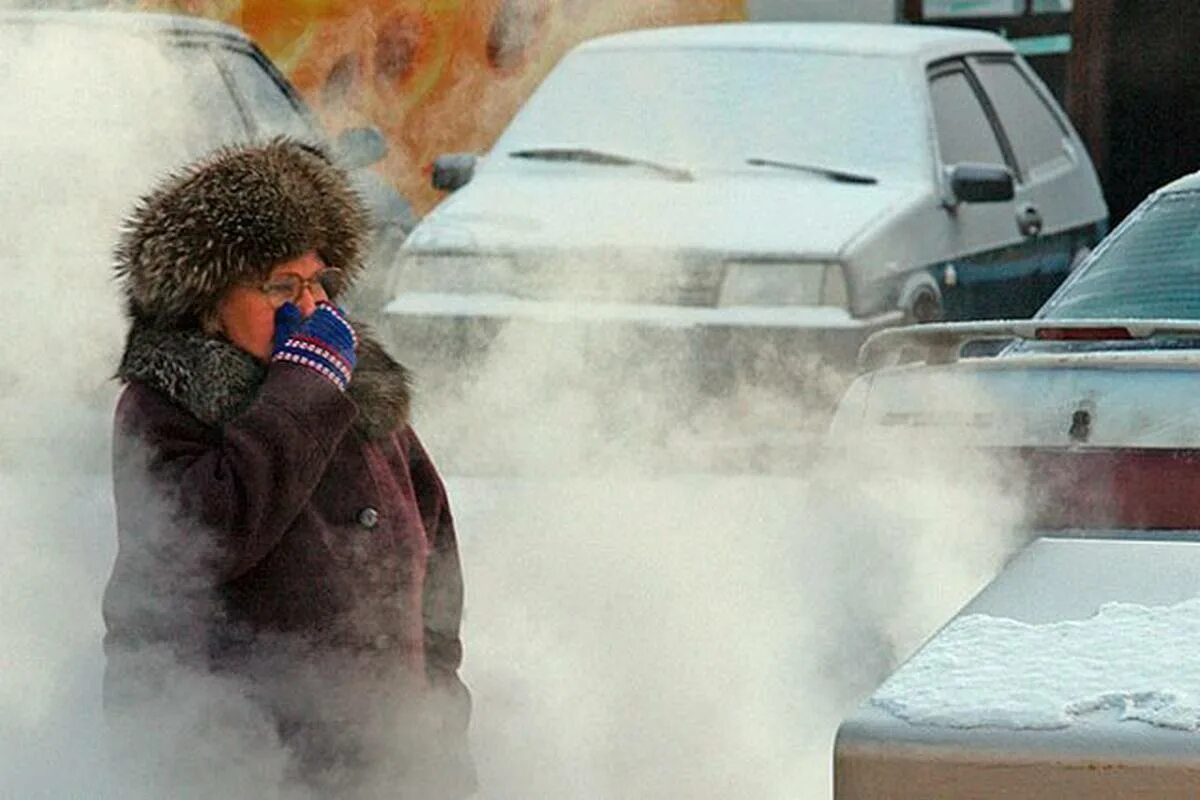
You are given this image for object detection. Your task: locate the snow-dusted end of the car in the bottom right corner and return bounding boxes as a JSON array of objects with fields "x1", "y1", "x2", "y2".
[{"x1": 834, "y1": 539, "x2": 1200, "y2": 800}]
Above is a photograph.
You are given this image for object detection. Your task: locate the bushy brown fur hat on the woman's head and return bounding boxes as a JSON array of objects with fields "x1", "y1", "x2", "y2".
[{"x1": 115, "y1": 137, "x2": 368, "y2": 327}]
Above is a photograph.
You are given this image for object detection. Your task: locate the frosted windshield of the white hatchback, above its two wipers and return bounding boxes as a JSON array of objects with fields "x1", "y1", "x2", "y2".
[{"x1": 494, "y1": 48, "x2": 931, "y2": 180}]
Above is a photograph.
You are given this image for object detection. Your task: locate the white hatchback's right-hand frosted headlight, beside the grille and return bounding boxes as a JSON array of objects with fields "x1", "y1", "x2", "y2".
[{"x1": 718, "y1": 261, "x2": 848, "y2": 308}]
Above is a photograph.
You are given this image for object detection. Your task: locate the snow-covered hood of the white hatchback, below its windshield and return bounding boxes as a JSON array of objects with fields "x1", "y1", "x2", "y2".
[{"x1": 408, "y1": 167, "x2": 916, "y2": 258}]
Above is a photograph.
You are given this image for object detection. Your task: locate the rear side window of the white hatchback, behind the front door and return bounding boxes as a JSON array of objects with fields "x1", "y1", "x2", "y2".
[{"x1": 972, "y1": 59, "x2": 1067, "y2": 175}]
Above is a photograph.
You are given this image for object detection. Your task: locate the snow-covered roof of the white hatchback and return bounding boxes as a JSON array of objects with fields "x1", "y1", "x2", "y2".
[{"x1": 580, "y1": 23, "x2": 1013, "y2": 62}]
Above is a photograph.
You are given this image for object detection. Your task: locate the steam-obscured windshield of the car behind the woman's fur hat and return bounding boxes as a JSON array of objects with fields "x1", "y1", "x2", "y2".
[{"x1": 0, "y1": 24, "x2": 246, "y2": 184}]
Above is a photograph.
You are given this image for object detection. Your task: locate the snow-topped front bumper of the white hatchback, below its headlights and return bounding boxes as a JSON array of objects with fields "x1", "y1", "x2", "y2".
[{"x1": 384, "y1": 291, "x2": 878, "y2": 330}]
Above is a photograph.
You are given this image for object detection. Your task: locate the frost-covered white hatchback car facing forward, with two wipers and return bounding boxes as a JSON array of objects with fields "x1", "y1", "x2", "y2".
[{"x1": 385, "y1": 24, "x2": 1108, "y2": 385}]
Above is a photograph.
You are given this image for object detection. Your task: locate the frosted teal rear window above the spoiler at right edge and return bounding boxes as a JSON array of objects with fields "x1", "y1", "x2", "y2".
[{"x1": 1039, "y1": 192, "x2": 1200, "y2": 319}]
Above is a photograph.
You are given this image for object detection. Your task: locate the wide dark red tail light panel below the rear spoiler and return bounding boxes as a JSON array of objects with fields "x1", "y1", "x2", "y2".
[{"x1": 1020, "y1": 449, "x2": 1200, "y2": 530}]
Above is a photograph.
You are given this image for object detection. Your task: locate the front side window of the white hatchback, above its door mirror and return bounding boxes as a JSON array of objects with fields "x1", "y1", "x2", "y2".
[{"x1": 929, "y1": 70, "x2": 1006, "y2": 166}]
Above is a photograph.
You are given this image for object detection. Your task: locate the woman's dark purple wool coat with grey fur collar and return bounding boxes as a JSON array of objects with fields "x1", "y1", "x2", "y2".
[{"x1": 103, "y1": 326, "x2": 469, "y2": 796}]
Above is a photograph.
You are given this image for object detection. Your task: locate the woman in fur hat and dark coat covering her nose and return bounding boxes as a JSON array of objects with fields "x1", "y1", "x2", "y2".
[{"x1": 103, "y1": 139, "x2": 473, "y2": 798}]
